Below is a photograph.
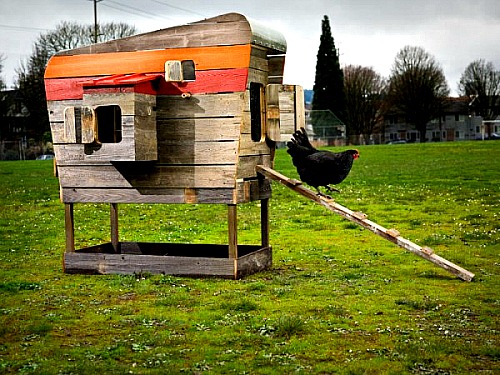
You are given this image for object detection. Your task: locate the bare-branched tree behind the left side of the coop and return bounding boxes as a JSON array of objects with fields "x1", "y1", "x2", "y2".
[{"x1": 16, "y1": 22, "x2": 136, "y2": 140}]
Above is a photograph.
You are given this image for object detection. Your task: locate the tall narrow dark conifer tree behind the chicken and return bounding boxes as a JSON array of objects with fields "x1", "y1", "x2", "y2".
[{"x1": 312, "y1": 16, "x2": 345, "y2": 136}]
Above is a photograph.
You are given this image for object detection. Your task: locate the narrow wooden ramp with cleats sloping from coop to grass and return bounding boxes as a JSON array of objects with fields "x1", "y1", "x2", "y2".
[{"x1": 256, "y1": 165, "x2": 474, "y2": 281}]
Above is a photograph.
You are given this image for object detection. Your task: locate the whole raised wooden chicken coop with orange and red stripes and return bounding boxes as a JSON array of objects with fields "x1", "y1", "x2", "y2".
[{"x1": 45, "y1": 13, "x2": 304, "y2": 278}]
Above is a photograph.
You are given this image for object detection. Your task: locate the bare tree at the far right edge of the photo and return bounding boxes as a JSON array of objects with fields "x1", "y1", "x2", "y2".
[{"x1": 458, "y1": 59, "x2": 500, "y2": 136}]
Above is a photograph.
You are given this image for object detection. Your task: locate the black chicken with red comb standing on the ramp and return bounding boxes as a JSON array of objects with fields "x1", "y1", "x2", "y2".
[{"x1": 287, "y1": 128, "x2": 359, "y2": 198}]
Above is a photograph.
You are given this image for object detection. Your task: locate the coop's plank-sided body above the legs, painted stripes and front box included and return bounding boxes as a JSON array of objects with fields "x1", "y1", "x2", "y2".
[{"x1": 45, "y1": 14, "x2": 284, "y2": 204}]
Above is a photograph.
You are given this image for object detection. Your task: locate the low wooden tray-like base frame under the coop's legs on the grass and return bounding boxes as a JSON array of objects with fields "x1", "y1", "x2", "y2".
[{"x1": 64, "y1": 242, "x2": 272, "y2": 279}]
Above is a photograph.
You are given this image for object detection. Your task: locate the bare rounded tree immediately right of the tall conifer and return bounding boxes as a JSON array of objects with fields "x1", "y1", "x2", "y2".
[{"x1": 344, "y1": 65, "x2": 386, "y2": 141}]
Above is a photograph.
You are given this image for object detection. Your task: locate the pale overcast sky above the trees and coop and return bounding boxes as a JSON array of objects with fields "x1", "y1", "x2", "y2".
[{"x1": 0, "y1": 0, "x2": 500, "y2": 95}]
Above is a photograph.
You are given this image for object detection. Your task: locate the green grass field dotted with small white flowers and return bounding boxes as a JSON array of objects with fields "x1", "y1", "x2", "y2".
[{"x1": 0, "y1": 141, "x2": 500, "y2": 374}]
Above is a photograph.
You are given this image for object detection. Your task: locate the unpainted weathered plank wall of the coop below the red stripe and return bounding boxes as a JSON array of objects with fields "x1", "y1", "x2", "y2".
[{"x1": 51, "y1": 89, "x2": 271, "y2": 203}]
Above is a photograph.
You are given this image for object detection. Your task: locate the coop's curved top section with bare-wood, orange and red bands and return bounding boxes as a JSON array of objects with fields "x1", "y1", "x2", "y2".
[{"x1": 45, "y1": 13, "x2": 286, "y2": 100}]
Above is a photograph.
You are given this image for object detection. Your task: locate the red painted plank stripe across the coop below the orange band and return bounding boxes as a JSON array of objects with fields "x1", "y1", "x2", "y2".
[{"x1": 45, "y1": 68, "x2": 248, "y2": 100}]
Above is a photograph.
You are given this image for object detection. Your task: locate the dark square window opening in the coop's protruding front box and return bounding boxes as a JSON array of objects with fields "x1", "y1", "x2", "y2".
[{"x1": 95, "y1": 105, "x2": 122, "y2": 143}]
